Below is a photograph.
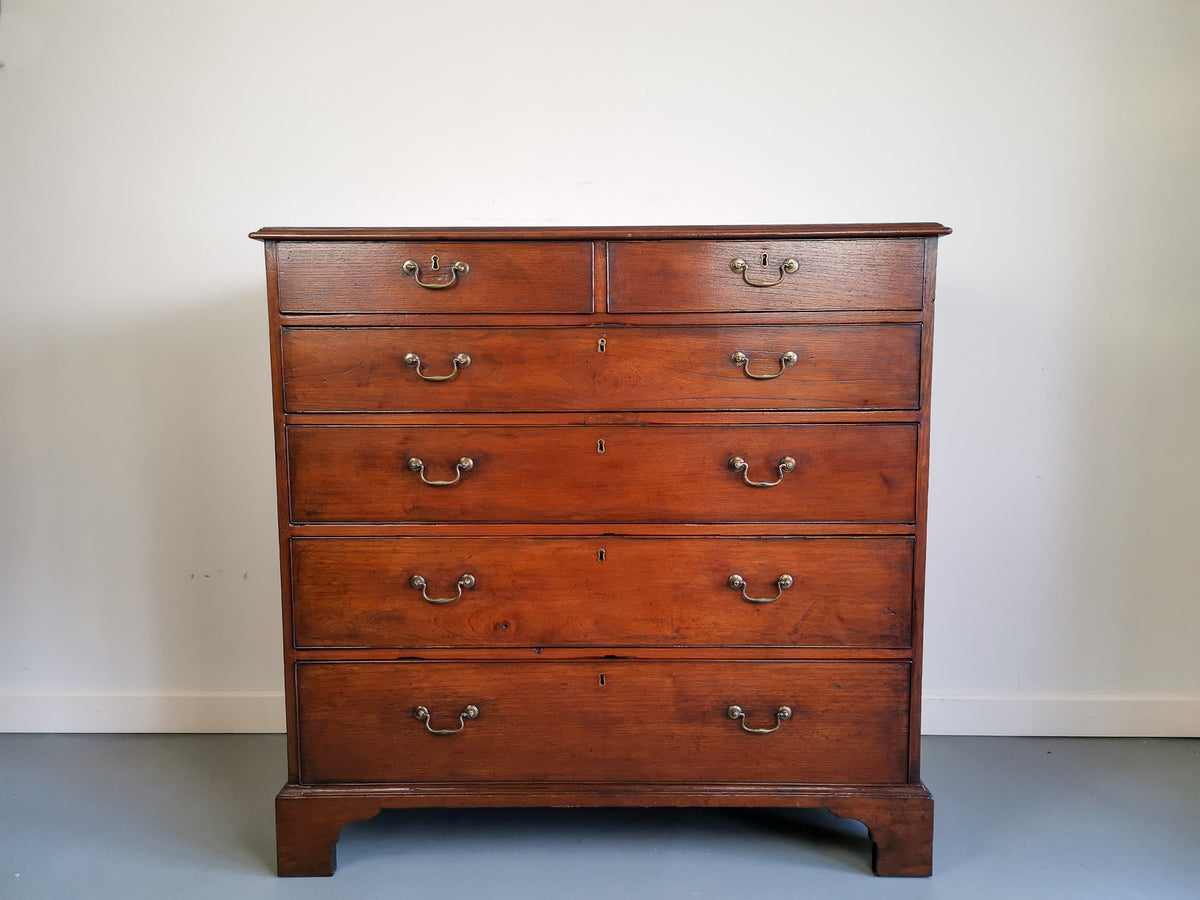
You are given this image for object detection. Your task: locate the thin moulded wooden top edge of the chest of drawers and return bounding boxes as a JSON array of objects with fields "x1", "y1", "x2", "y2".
[{"x1": 250, "y1": 222, "x2": 950, "y2": 241}]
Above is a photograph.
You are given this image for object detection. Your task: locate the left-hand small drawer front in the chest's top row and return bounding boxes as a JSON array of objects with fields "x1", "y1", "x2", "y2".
[{"x1": 276, "y1": 241, "x2": 593, "y2": 313}]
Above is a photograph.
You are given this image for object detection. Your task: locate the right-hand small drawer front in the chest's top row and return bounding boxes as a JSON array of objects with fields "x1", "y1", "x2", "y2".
[{"x1": 608, "y1": 240, "x2": 925, "y2": 312}]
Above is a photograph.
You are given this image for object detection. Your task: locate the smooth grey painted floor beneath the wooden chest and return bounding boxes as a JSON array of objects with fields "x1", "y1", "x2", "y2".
[{"x1": 0, "y1": 734, "x2": 1200, "y2": 900}]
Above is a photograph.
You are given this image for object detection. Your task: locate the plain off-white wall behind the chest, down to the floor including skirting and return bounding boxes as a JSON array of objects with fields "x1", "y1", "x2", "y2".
[{"x1": 0, "y1": 0, "x2": 1200, "y2": 734}]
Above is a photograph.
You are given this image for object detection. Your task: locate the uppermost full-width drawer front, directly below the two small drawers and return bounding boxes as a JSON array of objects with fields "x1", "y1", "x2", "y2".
[{"x1": 283, "y1": 325, "x2": 920, "y2": 413}]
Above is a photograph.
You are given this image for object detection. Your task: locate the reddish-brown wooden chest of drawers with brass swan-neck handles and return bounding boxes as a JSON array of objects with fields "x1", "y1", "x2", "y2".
[{"x1": 252, "y1": 223, "x2": 948, "y2": 875}]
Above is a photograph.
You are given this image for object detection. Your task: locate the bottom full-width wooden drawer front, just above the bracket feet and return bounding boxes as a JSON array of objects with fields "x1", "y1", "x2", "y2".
[{"x1": 296, "y1": 660, "x2": 910, "y2": 784}]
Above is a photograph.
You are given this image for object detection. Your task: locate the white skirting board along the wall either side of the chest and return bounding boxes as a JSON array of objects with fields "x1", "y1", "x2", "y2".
[{"x1": 0, "y1": 690, "x2": 1200, "y2": 738}]
